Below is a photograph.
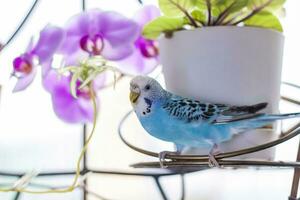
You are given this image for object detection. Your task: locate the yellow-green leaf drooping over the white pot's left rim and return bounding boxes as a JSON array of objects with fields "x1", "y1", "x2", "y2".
[{"x1": 143, "y1": 16, "x2": 185, "y2": 39}]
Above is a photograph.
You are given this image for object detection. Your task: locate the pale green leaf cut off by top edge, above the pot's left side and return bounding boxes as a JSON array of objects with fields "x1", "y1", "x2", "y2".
[{"x1": 158, "y1": 0, "x2": 197, "y2": 17}]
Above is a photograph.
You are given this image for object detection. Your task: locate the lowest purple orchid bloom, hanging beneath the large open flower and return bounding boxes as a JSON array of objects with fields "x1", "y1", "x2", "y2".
[{"x1": 43, "y1": 70, "x2": 99, "y2": 123}]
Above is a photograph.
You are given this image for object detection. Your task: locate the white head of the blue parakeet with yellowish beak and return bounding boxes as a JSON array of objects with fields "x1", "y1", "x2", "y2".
[{"x1": 129, "y1": 76, "x2": 166, "y2": 105}]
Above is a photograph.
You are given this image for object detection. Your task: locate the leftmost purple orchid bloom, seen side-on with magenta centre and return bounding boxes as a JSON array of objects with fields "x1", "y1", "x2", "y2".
[{"x1": 13, "y1": 25, "x2": 64, "y2": 92}]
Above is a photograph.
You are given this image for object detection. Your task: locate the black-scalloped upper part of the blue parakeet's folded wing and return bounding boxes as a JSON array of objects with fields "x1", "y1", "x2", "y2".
[{"x1": 163, "y1": 96, "x2": 228, "y2": 122}]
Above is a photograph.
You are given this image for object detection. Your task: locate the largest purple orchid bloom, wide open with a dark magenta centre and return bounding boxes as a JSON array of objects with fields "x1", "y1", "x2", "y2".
[{"x1": 61, "y1": 9, "x2": 139, "y2": 60}]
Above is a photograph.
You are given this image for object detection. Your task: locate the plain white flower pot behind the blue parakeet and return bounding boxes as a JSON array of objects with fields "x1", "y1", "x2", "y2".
[{"x1": 159, "y1": 26, "x2": 284, "y2": 159}]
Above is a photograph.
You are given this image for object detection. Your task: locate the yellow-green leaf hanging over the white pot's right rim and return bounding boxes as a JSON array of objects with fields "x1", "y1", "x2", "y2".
[{"x1": 244, "y1": 11, "x2": 283, "y2": 32}]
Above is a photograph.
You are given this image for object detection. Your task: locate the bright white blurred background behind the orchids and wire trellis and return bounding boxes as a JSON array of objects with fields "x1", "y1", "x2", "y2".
[{"x1": 0, "y1": 0, "x2": 300, "y2": 200}]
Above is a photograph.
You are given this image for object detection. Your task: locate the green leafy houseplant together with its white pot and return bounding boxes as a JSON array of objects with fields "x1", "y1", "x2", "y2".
[{"x1": 143, "y1": 0, "x2": 284, "y2": 159}]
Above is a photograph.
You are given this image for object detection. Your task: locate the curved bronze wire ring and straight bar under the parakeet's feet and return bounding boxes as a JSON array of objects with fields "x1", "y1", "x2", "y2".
[{"x1": 118, "y1": 110, "x2": 300, "y2": 168}]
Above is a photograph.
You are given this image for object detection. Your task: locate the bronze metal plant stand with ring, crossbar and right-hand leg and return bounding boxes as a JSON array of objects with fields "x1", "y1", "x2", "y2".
[{"x1": 119, "y1": 95, "x2": 300, "y2": 200}]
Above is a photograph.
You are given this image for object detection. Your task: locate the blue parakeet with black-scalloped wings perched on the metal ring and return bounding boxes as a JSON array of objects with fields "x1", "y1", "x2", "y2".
[{"x1": 130, "y1": 76, "x2": 300, "y2": 166}]
